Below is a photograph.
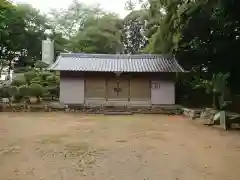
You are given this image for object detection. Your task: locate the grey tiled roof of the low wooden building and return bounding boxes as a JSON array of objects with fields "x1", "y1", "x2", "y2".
[{"x1": 50, "y1": 53, "x2": 184, "y2": 72}]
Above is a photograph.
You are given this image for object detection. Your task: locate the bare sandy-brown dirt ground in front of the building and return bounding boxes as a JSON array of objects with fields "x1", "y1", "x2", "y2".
[{"x1": 0, "y1": 113, "x2": 240, "y2": 180}]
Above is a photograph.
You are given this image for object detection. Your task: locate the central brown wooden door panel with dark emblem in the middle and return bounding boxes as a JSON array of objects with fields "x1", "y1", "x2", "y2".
[{"x1": 107, "y1": 78, "x2": 129, "y2": 101}]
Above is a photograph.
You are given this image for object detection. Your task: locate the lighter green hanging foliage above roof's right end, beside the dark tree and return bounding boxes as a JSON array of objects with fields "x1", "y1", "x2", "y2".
[{"x1": 145, "y1": 0, "x2": 180, "y2": 54}]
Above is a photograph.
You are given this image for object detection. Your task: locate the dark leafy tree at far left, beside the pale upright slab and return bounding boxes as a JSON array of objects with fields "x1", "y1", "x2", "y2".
[{"x1": 0, "y1": 0, "x2": 50, "y2": 70}]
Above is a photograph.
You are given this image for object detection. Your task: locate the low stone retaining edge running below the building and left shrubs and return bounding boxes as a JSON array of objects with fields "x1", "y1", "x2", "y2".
[{"x1": 1, "y1": 103, "x2": 182, "y2": 115}]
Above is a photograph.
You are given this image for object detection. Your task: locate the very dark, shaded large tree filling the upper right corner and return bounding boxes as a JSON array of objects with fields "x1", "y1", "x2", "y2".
[{"x1": 173, "y1": 0, "x2": 240, "y2": 91}]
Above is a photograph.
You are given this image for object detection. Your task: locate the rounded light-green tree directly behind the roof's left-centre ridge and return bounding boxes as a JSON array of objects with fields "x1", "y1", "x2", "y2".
[{"x1": 70, "y1": 14, "x2": 122, "y2": 54}]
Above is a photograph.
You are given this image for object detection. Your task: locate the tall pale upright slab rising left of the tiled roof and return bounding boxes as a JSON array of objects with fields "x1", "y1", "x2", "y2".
[{"x1": 42, "y1": 40, "x2": 54, "y2": 64}]
